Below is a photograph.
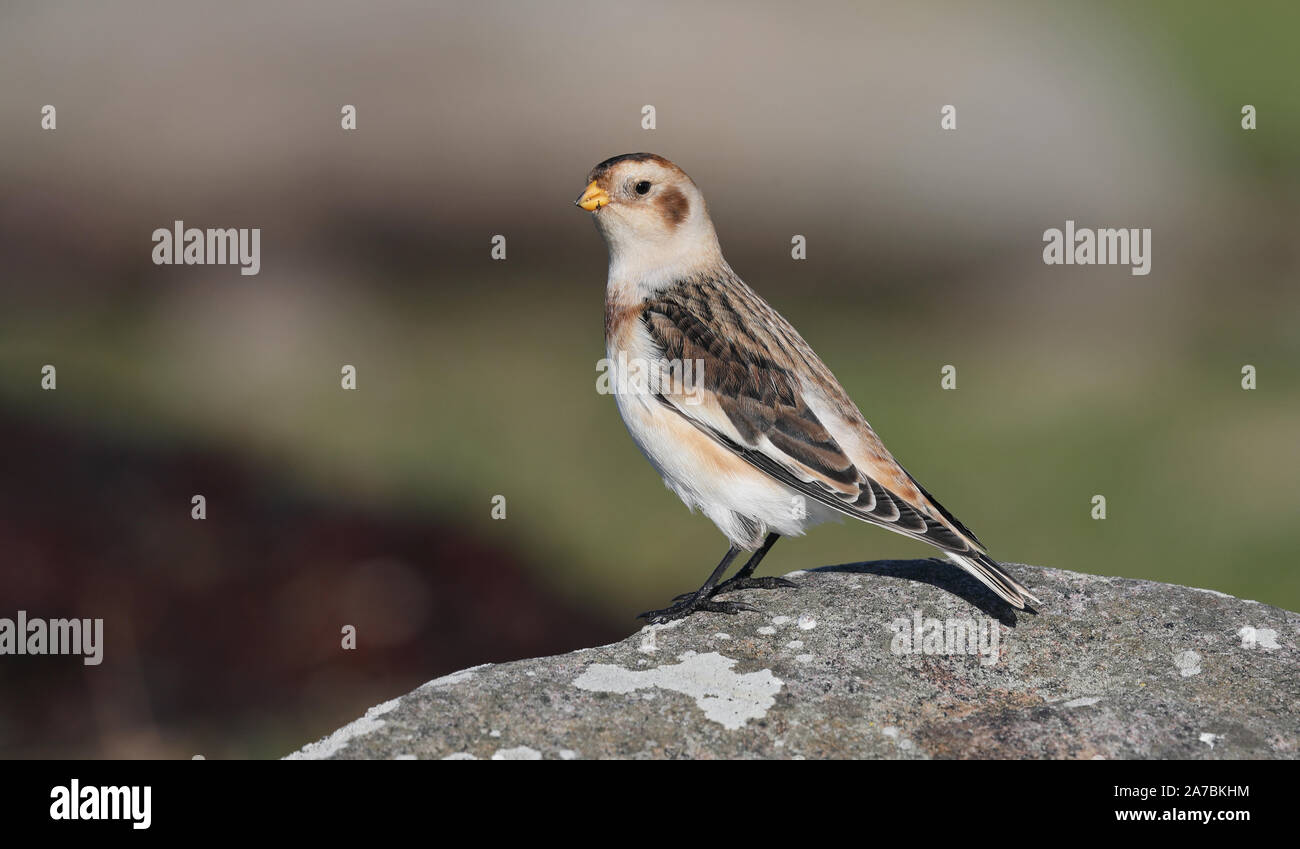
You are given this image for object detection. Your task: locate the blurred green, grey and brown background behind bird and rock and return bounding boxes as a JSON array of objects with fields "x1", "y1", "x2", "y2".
[{"x1": 0, "y1": 1, "x2": 1300, "y2": 757}]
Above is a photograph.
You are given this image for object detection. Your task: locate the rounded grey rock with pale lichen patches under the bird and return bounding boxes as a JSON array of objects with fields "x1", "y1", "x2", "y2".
[{"x1": 290, "y1": 560, "x2": 1300, "y2": 759}]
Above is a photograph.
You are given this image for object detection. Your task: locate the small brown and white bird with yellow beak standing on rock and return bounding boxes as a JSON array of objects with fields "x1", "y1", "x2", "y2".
[{"x1": 575, "y1": 153, "x2": 1041, "y2": 624}]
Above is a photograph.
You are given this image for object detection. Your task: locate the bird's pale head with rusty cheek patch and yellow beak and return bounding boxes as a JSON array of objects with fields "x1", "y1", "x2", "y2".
[{"x1": 575, "y1": 153, "x2": 720, "y2": 283}]
